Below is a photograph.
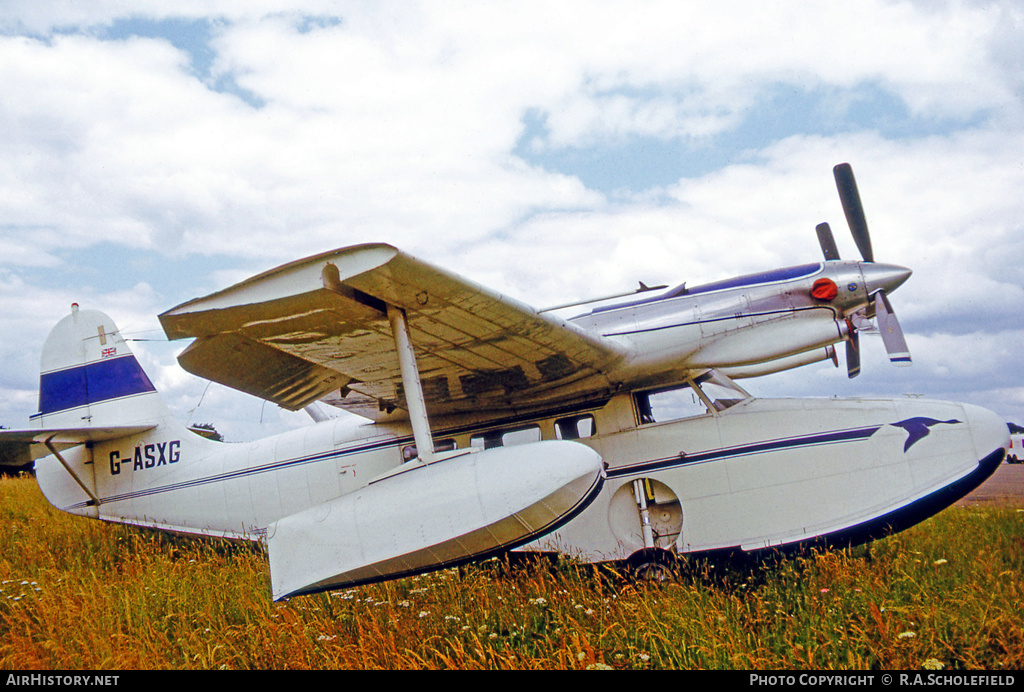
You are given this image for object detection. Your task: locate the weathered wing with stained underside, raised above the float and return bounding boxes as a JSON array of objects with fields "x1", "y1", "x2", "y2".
[{"x1": 160, "y1": 244, "x2": 626, "y2": 420}]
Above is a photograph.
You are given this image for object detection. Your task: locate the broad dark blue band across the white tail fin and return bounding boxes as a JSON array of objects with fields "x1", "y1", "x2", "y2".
[{"x1": 39, "y1": 355, "x2": 157, "y2": 414}]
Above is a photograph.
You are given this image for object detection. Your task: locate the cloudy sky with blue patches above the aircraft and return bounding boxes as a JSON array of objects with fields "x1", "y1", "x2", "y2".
[{"x1": 0, "y1": 0, "x2": 1024, "y2": 440}]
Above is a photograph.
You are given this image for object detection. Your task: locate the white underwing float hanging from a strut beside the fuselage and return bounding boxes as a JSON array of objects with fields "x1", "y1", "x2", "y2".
[{"x1": 267, "y1": 440, "x2": 604, "y2": 600}]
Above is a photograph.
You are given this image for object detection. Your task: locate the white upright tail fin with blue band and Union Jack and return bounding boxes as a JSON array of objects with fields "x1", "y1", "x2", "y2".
[{"x1": 32, "y1": 303, "x2": 172, "y2": 429}]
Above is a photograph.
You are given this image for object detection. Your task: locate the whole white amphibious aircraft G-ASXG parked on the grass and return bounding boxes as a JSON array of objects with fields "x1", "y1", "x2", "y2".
[{"x1": 0, "y1": 165, "x2": 1009, "y2": 599}]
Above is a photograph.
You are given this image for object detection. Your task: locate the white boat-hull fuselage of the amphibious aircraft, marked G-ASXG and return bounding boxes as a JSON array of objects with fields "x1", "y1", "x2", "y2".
[{"x1": 37, "y1": 378, "x2": 1009, "y2": 561}]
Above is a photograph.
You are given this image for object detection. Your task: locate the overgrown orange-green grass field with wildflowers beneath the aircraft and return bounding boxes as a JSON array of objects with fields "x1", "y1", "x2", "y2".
[{"x1": 0, "y1": 477, "x2": 1024, "y2": 671}]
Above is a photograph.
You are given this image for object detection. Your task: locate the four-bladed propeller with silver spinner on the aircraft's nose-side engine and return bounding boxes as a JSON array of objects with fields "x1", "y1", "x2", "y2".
[{"x1": 816, "y1": 164, "x2": 910, "y2": 378}]
